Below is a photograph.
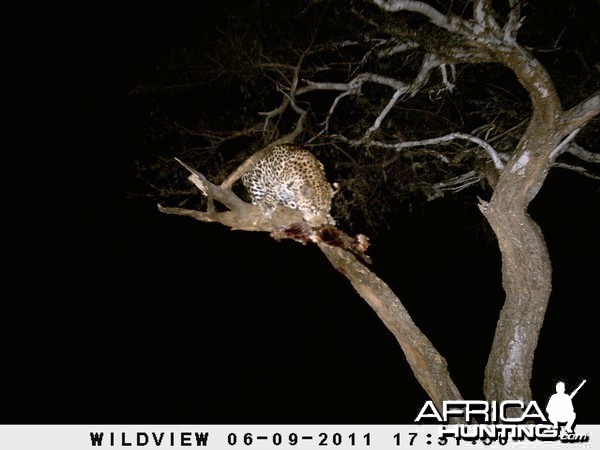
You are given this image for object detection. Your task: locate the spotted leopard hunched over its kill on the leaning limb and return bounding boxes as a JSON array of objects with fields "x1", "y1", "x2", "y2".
[{"x1": 242, "y1": 144, "x2": 336, "y2": 227}]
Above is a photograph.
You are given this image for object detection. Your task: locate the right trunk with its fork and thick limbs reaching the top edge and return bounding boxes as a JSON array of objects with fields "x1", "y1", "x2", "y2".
[{"x1": 370, "y1": 0, "x2": 600, "y2": 408}]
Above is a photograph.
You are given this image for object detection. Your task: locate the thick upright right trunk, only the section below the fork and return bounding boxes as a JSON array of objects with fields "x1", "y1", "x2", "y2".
[{"x1": 480, "y1": 117, "x2": 561, "y2": 402}]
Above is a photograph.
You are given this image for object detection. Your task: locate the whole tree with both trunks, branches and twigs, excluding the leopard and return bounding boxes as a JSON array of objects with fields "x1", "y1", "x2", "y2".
[{"x1": 138, "y1": 0, "x2": 600, "y2": 414}]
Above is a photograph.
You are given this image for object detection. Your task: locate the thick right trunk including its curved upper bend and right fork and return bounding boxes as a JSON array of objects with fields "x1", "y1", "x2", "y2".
[{"x1": 480, "y1": 40, "x2": 599, "y2": 402}]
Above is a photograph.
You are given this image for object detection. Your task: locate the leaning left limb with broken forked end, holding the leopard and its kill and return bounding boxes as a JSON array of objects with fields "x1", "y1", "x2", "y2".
[{"x1": 163, "y1": 156, "x2": 462, "y2": 408}]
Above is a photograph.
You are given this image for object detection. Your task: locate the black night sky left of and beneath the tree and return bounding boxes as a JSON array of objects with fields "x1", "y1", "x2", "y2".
[{"x1": 0, "y1": 1, "x2": 600, "y2": 423}]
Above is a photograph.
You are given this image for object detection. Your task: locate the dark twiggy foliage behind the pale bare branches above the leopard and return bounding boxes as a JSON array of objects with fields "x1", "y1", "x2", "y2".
[{"x1": 133, "y1": 0, "x2": 600, "y2": 232}]
